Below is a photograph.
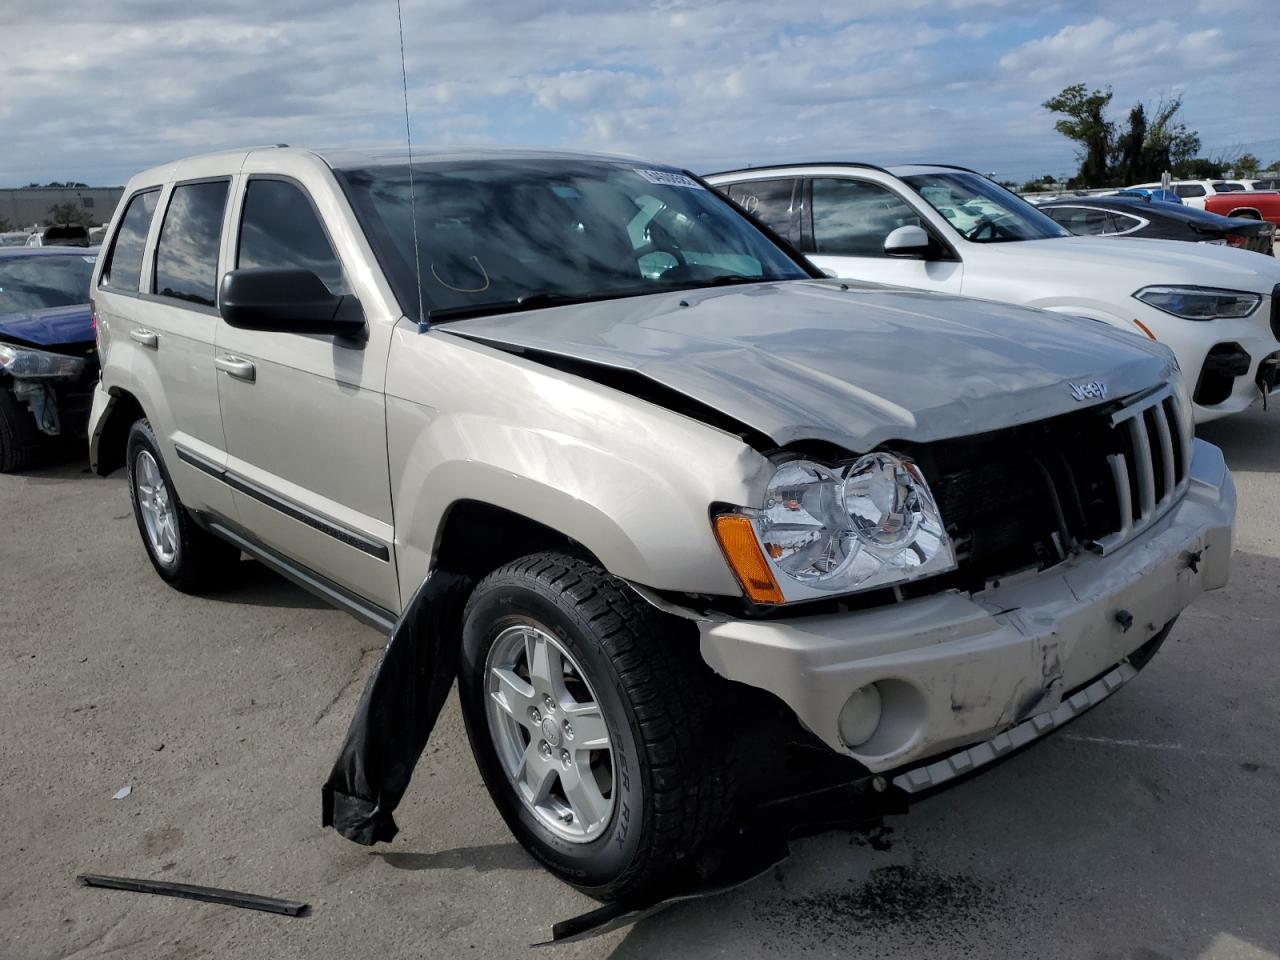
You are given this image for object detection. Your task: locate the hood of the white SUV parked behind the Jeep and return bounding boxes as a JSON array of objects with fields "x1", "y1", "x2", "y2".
[{"x1": 986, "y1": 237, "x2": 1280, "y2": 294}]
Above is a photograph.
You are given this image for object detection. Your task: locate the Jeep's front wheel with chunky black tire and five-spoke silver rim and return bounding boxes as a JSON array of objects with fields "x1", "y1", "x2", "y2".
[{"x1": 458, "y1": 553, "x2": 736, "y2": 900}]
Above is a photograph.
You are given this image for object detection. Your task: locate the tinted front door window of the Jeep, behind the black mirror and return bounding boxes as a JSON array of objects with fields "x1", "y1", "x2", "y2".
[{"x1": 236, "y1": 179, "x2": 351, "y2": 294}]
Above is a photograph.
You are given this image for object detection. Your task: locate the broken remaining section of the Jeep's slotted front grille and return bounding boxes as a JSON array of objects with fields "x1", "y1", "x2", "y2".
[{"x1": 1089, "y1": 384, "x2": 1192, "y2": 556}]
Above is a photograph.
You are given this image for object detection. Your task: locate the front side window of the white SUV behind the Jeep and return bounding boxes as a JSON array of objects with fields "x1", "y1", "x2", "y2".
[{"x1": 809, "y1": 178, "x2": 922, "y2": 257}]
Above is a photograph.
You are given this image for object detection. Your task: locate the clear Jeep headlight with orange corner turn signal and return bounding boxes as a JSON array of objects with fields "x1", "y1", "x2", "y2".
[{"x1": 717, "y1": 453, "x2": 956, "y2": 603}]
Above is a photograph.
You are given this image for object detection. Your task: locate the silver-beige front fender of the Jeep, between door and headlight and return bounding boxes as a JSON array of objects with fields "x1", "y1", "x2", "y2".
[{"x1": 387, "y1": 333, "x2": 769, "y2": 596}]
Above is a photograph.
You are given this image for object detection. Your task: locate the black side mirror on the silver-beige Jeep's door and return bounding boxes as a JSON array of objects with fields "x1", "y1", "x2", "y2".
[{"x1": 218, "y1": 266, "x2": 365, "y2": 337}]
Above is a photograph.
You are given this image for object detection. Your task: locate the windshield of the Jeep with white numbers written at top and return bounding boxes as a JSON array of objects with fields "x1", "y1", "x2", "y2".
[{"x1": 337, "y1": 159, "x2": 810, "y2": 319}]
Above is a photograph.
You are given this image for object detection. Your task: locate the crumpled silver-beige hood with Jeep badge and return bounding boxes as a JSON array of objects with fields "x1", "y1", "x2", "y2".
[{"x1": 436, "y1": 280, "x2": 1172, "y2": 452}]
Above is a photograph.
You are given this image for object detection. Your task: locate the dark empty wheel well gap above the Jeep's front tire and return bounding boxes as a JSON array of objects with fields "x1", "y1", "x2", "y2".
[{"x1": 433, "y1": 500, "x2": 603, "y2": 580}]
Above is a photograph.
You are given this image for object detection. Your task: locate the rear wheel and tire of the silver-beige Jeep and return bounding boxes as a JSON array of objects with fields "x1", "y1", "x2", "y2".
[{"x1": 125, "y1": 420, "x2": 239, "y2": 594}]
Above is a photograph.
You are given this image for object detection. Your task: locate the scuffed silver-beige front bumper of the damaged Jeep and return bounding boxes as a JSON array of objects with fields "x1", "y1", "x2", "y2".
[{"x1": 699, "y1": 440, "x2": 1235, "y2": 773}]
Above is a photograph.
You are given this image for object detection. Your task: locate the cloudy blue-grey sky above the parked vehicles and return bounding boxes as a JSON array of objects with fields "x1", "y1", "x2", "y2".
[{"x1": 0, "y1": 0, "x2": 1280, "y2": 186}]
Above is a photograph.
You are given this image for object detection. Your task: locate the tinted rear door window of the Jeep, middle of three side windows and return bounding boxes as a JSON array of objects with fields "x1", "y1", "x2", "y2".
[{"x1": 152, "y1": 180, "x2": 229, "y2": 307}]
